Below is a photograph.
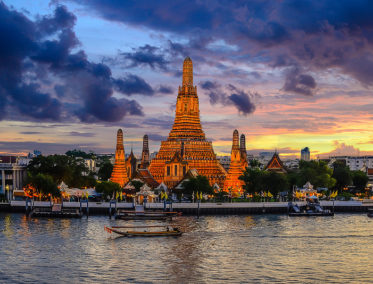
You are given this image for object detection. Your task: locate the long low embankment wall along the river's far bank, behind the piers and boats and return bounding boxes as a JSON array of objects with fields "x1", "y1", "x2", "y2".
[{"x1": 0, "y1": 201, "x2": 373, "y2": 215}]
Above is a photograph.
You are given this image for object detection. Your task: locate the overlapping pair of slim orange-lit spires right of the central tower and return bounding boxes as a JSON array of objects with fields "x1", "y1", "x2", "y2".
[{"x1": 224, "y1": 129, "x2": 248, "y2": 195}]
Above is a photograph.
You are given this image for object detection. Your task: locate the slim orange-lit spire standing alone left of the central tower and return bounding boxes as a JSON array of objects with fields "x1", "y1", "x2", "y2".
[{"x1": 110, "y1": 129, "x2": 129, "y2": 187}]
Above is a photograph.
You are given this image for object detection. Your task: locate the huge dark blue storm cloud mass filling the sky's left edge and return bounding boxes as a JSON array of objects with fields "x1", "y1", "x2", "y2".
[{"x1": 0, "y1": 2, "x2": 147, "y2": 122}]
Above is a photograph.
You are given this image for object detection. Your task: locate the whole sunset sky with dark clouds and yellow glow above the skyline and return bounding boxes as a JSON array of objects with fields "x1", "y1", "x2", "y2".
[{"x1": 0, "y1": 0, "x2": 373, "y2": 158}]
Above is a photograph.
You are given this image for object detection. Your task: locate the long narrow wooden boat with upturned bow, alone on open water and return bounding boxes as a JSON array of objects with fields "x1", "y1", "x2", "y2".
[{"x1": 104, "y1": 226, "x2": 182, "y2": 237}]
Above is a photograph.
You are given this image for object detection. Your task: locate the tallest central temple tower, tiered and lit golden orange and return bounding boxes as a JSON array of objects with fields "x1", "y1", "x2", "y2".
[{"x1": 149, "y1": 57, "x2": 226, "y2": 188}]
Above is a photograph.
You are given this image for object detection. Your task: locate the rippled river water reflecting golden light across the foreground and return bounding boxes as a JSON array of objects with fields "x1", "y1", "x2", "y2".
[{"x1": 0, "y1": 213, "x2": 373, "y2": 283}]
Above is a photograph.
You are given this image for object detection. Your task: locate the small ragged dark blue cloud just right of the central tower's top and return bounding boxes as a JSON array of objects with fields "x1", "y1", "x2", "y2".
[{"x1": 200, "y1": 81, "x2": 259, "y2": 115}]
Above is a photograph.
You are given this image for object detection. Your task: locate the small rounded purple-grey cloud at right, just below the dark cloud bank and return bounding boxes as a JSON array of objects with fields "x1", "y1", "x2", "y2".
[{"x1": 283, "y1": 68, "x2": 316, "y2": 96}]
